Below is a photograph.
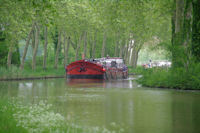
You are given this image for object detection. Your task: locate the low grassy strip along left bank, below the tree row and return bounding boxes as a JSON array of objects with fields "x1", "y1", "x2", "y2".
[{"x1": 0, "y1": 66, "x2": 65, "y2": 79}]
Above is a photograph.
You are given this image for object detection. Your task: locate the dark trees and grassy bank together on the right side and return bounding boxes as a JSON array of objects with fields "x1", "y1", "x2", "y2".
[{"x1": 134, "y1": 0, "x2": 200, "y2": 89}]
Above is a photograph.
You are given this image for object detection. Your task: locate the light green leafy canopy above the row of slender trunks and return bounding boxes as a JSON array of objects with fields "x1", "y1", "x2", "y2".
[{"x1": 0, "y1": 0, "x2": 171, "y2": 68}]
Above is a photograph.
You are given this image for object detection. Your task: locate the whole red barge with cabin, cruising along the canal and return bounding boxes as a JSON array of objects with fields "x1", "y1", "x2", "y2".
[{"x1": 65, "y1": 57, "x2": 128, "y2": 79}]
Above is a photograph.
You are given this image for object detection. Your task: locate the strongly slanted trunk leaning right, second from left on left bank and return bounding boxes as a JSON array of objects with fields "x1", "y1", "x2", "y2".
[{"x1": 20, "y1": 24, "x2": 35, "y2": 70}]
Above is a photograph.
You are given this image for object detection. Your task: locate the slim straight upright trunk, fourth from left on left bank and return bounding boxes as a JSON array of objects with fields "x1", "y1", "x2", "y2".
[{"x1": 43, "y1": 26, "x2": 48, "y2": 69}]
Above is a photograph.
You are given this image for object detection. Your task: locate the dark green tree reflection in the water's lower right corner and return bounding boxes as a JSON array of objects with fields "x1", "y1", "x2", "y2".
[{"x1": 172, "y1": 92, "x2": 200, "y2": 133}]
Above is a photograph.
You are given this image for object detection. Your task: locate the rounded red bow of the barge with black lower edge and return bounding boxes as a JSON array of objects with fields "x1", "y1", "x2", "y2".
[{"x1": 66, "y1": 60, "x2": 105, "y2": 79}]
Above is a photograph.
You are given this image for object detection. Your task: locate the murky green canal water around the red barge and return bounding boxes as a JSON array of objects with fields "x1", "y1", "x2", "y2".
[{"x1": 0, "y1": 78, "x2": 200, "y2": 133}]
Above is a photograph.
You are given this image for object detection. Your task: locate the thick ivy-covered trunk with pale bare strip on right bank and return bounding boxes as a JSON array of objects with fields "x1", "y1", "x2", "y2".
[{"x1": 172, "y1": 0, "x2": 193, "y2": 69}]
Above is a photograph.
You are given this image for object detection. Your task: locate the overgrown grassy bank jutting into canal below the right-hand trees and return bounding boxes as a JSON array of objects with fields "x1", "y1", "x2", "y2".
[{"x1": 130, "y1": 63, "x2": 200, "y2": 90}]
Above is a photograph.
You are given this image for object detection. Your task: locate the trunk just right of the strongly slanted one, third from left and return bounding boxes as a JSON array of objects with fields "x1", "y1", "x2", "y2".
[{"x1": 32, "y1": 24, "x2": 40, "y2": 70}]
